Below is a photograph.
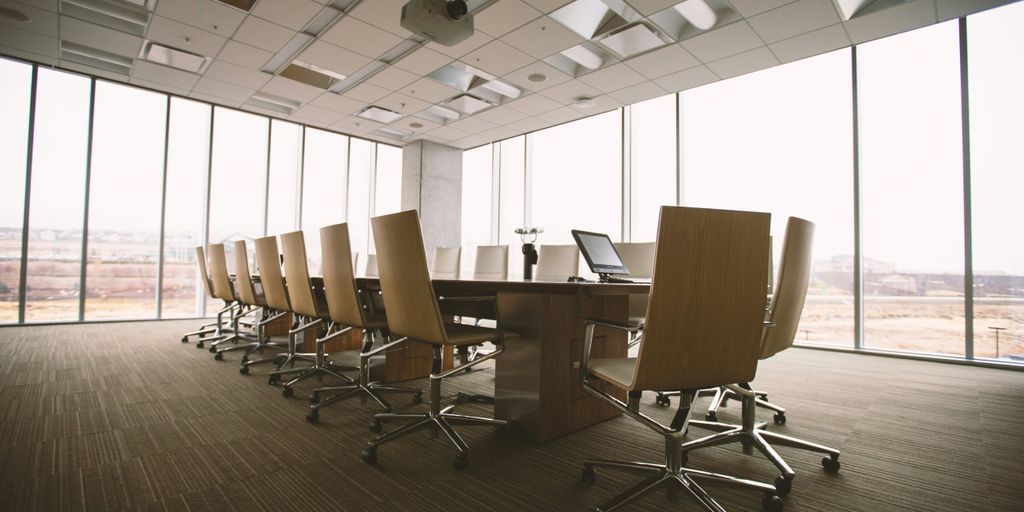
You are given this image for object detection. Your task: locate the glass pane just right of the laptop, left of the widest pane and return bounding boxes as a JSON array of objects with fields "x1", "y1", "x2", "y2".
[{"x1": 630, "y1": 94, "x2": 677, "y2": 242}]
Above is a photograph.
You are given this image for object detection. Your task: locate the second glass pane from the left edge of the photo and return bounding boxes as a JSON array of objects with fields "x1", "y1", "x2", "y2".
[{"x1": 25, "y1": 68, "x2": 90, "y2": 322}]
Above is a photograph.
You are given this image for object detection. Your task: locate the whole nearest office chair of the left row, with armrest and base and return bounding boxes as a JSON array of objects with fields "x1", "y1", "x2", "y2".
[{"x1": 362, "y1": 210, "x2": 511, "y2": 469}]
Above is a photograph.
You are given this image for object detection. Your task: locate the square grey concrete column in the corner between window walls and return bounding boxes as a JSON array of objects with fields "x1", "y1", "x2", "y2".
[{"x1": 401, "y1": 140, "x2": 462, "y2": 262}]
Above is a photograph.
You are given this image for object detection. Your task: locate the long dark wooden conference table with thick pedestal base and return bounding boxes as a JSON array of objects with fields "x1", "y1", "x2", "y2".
[{"x1": 356, "y1": 278, "x2": 650, "y2": 442}]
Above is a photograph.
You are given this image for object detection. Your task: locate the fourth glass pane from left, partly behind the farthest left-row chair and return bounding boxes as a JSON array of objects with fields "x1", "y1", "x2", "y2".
[{"x1": 161, "y1": 97, "x2": 213, "y2": 318}]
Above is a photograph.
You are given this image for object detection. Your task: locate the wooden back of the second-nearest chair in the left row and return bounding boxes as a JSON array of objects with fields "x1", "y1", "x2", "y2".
[{"x1": 321, "y1": 224, "x2": 366, "y2": 328}]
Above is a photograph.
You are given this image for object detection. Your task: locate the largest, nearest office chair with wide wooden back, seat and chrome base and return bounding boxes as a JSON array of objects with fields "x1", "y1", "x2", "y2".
[{"x1": 580, "y1": 207, "x2": 782, "y2": 512}]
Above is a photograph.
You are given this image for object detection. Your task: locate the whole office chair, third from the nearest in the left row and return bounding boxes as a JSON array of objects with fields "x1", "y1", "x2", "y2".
[{"x1": 269, "y1": 231, "x2": 357, "y2": 397}]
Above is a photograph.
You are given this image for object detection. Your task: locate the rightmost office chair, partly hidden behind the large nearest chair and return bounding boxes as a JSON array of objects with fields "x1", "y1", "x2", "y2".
[{"x1": 682, "y1": 217, "x2": 840, "y2": 495}]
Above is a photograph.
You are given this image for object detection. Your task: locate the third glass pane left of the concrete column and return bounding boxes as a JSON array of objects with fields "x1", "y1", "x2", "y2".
[{"x1": 302, "y1": 128, "x2": 348, "y2": 274}]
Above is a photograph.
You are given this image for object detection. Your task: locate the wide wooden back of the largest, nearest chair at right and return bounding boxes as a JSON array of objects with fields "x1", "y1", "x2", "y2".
[{"x1": 631, "y1": 206, "x2": 771, "y2": 390}]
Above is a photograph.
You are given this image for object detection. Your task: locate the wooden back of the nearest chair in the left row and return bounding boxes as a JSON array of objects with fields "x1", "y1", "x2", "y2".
[{"x1": 370, "y1": 210, "x2": 446, "y2": 344}]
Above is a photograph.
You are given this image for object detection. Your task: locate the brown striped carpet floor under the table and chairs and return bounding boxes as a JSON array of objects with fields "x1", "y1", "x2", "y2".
[{"x1": 0, "y1": 322, "x2": 1024, "y2": 512}]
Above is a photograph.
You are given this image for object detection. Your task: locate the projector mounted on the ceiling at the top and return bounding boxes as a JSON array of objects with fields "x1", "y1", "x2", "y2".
[{"x1": 401, "y1": 0, "x2": 473, "y2": 46}]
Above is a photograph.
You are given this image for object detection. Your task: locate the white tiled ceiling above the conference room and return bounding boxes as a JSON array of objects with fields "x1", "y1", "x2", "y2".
[{"x1": 0, "y1": 0, "x2": 1010, "y2": 148}]
